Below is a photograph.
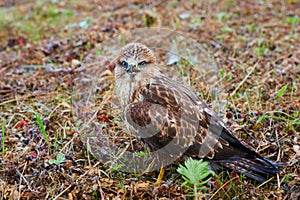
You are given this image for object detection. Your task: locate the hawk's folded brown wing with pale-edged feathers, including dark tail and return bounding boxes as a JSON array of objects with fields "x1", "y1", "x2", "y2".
[{"x1": 125, "y1": 75, "x2": 279, "y2": 181}]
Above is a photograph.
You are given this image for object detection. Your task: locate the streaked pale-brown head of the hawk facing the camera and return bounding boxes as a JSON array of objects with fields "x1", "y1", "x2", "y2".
[{"x1": 115, "y1": 43, "x2": 157, "y2": 77}]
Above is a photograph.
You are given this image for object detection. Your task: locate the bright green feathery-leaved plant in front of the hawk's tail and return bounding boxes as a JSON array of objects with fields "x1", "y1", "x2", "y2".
[{"x1": 177, "y1": 158, "x2": 214, "y2": 199}]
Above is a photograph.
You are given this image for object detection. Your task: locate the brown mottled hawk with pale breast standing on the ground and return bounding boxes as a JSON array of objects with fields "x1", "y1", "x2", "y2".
[{"x1": 114, "y1": 43, "x2": 280, "y2": 182}]
